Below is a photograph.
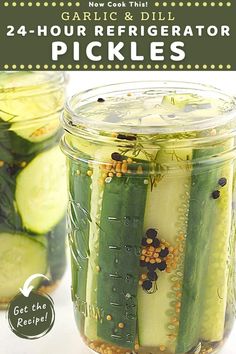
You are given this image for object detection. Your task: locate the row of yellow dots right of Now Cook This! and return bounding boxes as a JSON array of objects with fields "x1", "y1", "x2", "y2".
[{"x1": 154, "y1": 1, "x2": 232, "y2": 7}]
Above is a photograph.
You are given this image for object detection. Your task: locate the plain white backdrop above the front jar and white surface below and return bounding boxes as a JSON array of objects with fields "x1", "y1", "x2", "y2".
[{"x1": 0, "y1": 71, "x2": 236, "y2": 354}]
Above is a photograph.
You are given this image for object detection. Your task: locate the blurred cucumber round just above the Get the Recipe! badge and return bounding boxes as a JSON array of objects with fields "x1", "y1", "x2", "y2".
[{"x1": 0, "y1": 233, "x2": 47, "y2": 298}]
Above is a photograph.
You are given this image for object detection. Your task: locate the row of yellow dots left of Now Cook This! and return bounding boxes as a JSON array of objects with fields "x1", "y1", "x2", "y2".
[{"x1": 0, "y1": 1, "x2": 80, "y2": 7}]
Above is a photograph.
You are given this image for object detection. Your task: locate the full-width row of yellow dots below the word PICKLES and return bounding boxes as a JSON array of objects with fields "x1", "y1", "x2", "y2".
[{"x1": 0, "y1": 64, "x2": 232, "y2": 70}]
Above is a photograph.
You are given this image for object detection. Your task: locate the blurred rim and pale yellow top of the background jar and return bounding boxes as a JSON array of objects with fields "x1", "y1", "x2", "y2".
[{"x1": 0, "y1": 71, "x2": 67, "y2": 131}]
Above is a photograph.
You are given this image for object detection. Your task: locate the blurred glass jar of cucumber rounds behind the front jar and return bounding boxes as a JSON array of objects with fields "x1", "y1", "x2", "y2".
[{"x1": 0, "y1": 71, "x2": 67, "y2": 307}]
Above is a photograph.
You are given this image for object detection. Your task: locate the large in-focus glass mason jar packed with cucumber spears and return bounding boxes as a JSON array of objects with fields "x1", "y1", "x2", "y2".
[{"x1": 62, "y1": 82, "x2": 236, "y2": 354}]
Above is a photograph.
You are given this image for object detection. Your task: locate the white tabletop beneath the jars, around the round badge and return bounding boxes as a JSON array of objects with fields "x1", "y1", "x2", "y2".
[{"x1": 0, "y1": 272, "x2": 236, "y2": 354}]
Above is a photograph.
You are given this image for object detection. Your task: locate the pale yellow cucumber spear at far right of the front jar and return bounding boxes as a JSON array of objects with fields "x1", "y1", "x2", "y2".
[{"x1": 200, "y1": 140, "x2": 233, "y2": 342}]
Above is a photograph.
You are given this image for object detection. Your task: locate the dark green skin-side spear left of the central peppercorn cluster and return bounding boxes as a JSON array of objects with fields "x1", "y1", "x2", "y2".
[{"x1": 97, "y1": 175, "x2": 147, "y2": 349}]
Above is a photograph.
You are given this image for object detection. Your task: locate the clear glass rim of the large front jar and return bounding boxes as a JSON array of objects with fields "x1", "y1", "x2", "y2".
[{"x1": 62, "y1": 80, "x2": 236, "y2": 138}]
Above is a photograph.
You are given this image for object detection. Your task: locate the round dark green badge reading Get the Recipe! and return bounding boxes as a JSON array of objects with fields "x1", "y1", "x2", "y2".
[{"x1": 8, "y1": 291, "x2": 55, "y2": 339}]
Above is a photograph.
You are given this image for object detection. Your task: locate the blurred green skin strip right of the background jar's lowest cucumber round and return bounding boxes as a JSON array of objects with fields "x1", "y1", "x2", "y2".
[{"x1": 46, "y1": 217, "x2": 66, "y2": 282}]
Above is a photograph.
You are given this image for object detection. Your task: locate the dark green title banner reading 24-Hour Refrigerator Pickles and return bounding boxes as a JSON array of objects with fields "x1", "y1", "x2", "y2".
[{"x1": 0, "y1": 0, "x2": 236, "y2": 70}]
